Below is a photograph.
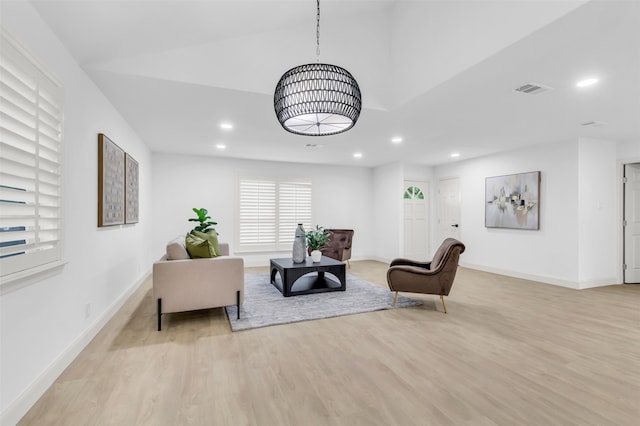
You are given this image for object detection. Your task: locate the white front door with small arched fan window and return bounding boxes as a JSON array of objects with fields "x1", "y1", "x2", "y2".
[{"x1": 403, "y1": 181, "x2": 429, "y2": 260}]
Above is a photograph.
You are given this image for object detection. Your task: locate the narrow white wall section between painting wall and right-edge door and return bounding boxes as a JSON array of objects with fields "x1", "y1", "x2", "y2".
[{"x1": 578, "y1": 139, "x2": 620, "y2": 288}]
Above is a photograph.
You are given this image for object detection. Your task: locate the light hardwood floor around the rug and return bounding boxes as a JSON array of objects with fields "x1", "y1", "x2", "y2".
[{"x1": 20, "y1": 261, "x2": 640, "y2": 426}]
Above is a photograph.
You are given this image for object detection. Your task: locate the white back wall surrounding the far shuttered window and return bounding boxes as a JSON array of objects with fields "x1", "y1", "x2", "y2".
[{"x1": 152, "y1": 153, "x2": 376, "y2": 266}]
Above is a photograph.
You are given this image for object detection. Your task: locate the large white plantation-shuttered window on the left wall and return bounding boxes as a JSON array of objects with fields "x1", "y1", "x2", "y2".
[{"x1": 0, "y1": 33, "x2": 63, "y2": 282}]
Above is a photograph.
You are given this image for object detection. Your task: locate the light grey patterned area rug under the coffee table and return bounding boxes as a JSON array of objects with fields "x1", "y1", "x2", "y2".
[{"x1": 226, "y1": 272, "x2": 422, "y2": 331}]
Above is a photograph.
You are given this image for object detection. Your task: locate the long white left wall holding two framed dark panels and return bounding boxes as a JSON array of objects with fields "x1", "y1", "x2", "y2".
[{"x1": 0, "y1": 1, "x2": 151, "y2": 424}]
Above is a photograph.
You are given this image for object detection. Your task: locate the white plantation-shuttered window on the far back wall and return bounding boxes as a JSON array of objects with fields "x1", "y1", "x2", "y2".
[{"x1": 238, "y1": 178, "x2": 313, "y2": 252}]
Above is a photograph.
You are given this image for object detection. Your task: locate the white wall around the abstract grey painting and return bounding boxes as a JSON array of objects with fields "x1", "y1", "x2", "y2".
[{"x1": 435, "y1": 141, "x2": 580, "y2": 288}]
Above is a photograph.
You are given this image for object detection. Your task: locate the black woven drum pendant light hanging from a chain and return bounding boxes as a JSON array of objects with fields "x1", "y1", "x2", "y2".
[{"x1": 273, "y1": 0, "x2": 362, "y2": 136}]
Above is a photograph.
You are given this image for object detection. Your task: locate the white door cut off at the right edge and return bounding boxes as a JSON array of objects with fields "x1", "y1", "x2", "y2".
[{"x1": 624, "y1": 164, "x2": 640, "y2": 283}]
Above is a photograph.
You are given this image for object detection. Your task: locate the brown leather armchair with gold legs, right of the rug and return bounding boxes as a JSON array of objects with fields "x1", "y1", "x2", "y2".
[{"x1": 387, "y1": 238, "x2": 465, "y2": 314}]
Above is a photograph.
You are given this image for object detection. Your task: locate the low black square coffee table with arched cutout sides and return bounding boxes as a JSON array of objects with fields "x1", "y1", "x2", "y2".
[{"x1": 271, "y1": 256, "x2": 347, "y2": 297}]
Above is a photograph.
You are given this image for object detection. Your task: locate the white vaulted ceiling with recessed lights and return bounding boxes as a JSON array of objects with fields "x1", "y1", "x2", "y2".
[{"x1": 27, "y1": 0, "x2": 640, "y2": 167}]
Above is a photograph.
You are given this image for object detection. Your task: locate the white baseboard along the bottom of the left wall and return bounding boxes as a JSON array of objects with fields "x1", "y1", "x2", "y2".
[{"x1": 0, "y1": 270, "x2": 151, "y2": 426}]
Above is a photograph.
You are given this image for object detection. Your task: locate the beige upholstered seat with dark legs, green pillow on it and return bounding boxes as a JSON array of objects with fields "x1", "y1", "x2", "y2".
[{"x1": 153, "y1": 236, "x2": 244, "y2": 331}]
